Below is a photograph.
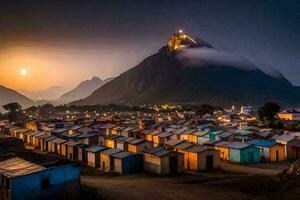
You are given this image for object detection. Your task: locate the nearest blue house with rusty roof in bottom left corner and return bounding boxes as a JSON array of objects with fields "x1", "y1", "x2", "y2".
[{"x1": 0, "y1": 157, "x2": 80, "y2": 200}]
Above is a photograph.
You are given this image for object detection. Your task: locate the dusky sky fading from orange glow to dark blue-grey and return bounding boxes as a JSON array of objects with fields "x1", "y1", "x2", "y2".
[{"x1": 0, "y1": 0, "x2": 300, "y2": 91}]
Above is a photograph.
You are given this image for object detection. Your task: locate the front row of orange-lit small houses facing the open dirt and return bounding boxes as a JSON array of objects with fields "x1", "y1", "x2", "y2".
[{"x1": 7, "y1": 128, "x2": 220, "y2": 175}]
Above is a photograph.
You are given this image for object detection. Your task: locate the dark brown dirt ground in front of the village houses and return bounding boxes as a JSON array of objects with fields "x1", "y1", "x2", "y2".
[{"x1": 81, "y1": 162, "x2": 297, "y2": 200}]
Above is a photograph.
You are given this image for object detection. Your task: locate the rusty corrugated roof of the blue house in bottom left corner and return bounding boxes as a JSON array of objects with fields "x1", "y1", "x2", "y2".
[{"x1": 0, "y1": 157, "x2": 46, "y2": 178}]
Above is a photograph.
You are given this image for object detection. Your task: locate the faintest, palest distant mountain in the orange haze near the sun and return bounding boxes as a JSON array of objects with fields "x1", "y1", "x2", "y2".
[{"x1": 19, "y1": 86, "x2": 66, "y2": 100}]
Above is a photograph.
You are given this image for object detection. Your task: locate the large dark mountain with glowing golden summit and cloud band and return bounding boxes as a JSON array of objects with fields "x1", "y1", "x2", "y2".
[{"x1": 71, "y1": 32, "x2": 300, "y2": 106}]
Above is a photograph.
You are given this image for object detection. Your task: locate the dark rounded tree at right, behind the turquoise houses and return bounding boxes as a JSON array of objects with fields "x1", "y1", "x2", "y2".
[{"x1": 257, "y1": 102, "x2": 280, "y2": 127}]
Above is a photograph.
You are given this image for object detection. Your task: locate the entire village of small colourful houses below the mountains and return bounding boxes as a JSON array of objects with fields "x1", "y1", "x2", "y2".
[{"x1": 0, "y1": 105, "x2": 300, "y2": 199}]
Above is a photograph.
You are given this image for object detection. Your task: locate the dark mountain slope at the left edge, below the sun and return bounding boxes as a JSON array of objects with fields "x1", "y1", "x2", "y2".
[{"x1": 0, "y1": 85, "x2": 34, "y2": 109}]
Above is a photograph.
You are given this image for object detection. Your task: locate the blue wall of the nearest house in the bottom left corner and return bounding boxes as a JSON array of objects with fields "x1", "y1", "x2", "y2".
[{"x1": 11, "y1": 165, "x2": 80, "y2": 200}]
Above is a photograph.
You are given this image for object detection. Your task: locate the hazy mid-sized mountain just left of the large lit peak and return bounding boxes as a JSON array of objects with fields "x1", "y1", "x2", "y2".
[{"x1": 56, "y1": 77, "x2": 113, "y2": 104}]
